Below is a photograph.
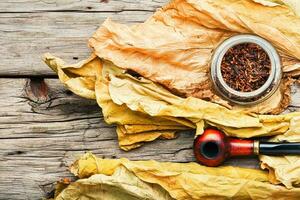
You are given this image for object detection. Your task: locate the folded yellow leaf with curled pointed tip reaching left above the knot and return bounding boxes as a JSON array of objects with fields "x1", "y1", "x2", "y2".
[{"x1": 44, "y1": 54, "x2": 195, "y2": 151}]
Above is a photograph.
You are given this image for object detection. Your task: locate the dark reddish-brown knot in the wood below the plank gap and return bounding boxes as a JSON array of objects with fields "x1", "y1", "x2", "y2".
[{"x1": 25, "y1": 78, "x2": 50, "y2": 104}]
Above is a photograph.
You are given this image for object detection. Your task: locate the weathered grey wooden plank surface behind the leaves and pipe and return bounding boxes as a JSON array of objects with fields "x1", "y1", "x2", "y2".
[{"x1": 0, "y1": 0, "x2": 300, "y2": 199}]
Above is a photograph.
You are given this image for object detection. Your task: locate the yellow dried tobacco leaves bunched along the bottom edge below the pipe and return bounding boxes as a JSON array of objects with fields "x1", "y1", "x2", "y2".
[{"x1": 61, "y1": 153, "x2": 300, "y2": 200}]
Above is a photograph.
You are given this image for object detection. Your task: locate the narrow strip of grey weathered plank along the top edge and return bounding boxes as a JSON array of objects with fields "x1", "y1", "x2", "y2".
[{"x1": 0, "y1": 0, "x2": 168, "y2": 12}]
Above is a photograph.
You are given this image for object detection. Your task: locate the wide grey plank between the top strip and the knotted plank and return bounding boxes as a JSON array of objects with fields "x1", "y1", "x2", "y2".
[{"x1": 0, "y1": 11, "x2": 155, "y2": 77}]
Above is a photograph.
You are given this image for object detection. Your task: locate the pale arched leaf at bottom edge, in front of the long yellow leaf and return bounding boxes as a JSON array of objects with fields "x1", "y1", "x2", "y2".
[{"x1": 55, "y1": 167, "x2": 173, "y2": 200}]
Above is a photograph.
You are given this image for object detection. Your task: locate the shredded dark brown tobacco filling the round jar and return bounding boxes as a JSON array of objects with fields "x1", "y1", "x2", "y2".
[{"x1": 221, "y1": 43, "x2": 271, "y2": 92}]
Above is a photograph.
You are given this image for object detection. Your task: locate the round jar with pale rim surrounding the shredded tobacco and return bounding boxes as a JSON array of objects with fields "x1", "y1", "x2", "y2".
[{"x1": 210, "y1": 34, "x2": 282, "y2": 105}]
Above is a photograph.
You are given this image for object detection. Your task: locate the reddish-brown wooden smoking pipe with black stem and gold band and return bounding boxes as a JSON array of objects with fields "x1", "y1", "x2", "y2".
[{"x1": 194, "y1": 128, "x2": 300, "y2": 167}]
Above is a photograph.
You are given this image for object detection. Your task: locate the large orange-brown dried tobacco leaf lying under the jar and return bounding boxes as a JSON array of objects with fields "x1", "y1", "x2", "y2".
[{"x1": 89, "y1": 0, "x2": 300, "y2": 113}]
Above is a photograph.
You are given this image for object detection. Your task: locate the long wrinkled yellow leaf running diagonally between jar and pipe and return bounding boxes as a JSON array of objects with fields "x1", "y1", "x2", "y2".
[{"x1": 109, "y1": 67, "x2": 300, "y2": 138}]
